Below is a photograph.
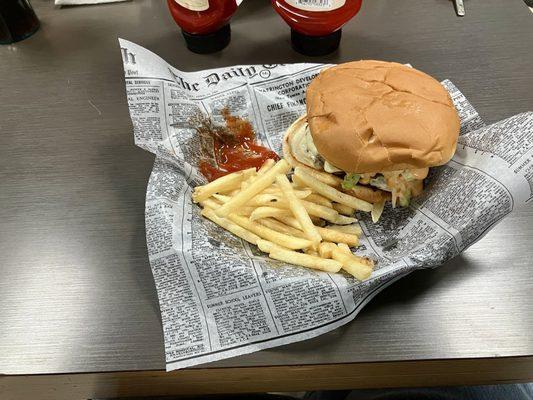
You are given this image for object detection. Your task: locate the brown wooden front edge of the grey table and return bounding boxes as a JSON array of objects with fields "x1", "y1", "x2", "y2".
[{"x1": 0, "y1": 356, "x2": 533, "y2": 400}]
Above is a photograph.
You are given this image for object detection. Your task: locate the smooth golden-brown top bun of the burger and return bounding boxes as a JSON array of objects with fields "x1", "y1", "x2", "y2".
[{"x1": 307, "y1": 60, "x2": 460, "y2": 173}]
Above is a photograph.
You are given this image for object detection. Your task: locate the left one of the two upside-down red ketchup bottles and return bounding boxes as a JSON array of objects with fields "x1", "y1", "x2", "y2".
[{"x1": 167, "y1": 0, "x2": 242, "y2": 54}]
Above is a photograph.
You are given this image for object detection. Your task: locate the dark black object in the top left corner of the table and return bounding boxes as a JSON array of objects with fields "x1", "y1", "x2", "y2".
[{"x1": 0, "y1": 0, "x2": 40, "y2": 44}]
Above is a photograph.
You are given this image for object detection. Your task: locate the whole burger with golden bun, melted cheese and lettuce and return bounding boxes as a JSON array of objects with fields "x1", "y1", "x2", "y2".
[{"x1": 283, "y1": 60, "x2": 460, "y2": 207}]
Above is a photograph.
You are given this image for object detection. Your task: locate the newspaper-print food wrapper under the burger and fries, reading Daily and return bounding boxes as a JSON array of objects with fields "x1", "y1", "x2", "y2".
[{"x1": 120, "y1": 40, "x2": 533, "y2": 370}]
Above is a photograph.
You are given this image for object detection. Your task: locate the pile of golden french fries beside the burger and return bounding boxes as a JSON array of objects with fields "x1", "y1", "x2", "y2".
[{"x1": 193, "y1": 159, "x2": 380, "y2": 280}]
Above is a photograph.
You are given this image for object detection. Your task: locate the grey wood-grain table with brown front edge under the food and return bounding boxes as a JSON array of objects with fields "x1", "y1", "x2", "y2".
[{"x1": 0, "y1": 0, "x2": 533, "y2": 399}]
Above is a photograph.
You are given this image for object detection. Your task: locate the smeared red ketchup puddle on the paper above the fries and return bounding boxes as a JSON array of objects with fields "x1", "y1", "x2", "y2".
[{"x1": 199, "y1": 109, "x2": 279, "y2": 182}]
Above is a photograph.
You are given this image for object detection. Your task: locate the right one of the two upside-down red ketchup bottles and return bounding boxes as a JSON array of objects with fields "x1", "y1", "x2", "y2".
[{"x1": 271, "y1": 0, "x2": 363, "y2": 56}]
